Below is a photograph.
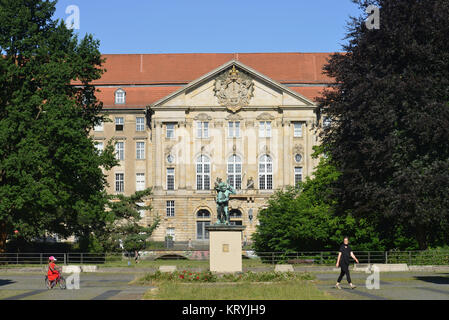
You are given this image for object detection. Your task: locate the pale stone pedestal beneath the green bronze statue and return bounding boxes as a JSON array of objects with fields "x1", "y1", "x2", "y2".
[{"x1": 206, "y1": 225, "x2": 245, "y2": 273}]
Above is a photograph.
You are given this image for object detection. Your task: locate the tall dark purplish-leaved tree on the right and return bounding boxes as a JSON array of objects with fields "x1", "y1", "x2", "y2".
[{"x1": 320, "y1": 0, "x2": 449, "y2": 249}]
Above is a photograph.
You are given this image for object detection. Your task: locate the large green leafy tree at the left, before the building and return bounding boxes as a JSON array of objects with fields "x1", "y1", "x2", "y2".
[{"x1": 0, "y1": 0, "x2": 115, "y2": 250}]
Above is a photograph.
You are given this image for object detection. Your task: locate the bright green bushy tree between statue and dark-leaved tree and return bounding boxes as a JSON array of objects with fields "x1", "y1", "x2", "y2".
[{"x1": 253, "y1": 147, "x2": 383, "y2": 252}]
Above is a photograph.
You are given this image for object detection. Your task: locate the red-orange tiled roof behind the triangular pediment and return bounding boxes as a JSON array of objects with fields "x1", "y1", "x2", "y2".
[{"x1": 85, "y1": 53, "x2": 332, "y2": 109}]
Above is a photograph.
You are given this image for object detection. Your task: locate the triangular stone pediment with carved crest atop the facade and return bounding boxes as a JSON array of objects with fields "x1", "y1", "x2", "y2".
[{"x1": 150, "y1": 60, "x2": 315, "y2": 110}]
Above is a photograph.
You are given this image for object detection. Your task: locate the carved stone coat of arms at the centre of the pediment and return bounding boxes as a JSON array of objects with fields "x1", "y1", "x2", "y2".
[{"x1": 214, "y1": 66, "x2": 254, "y2": 113}]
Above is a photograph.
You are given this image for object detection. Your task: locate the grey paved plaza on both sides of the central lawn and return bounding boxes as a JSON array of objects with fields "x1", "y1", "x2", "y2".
[{"x1": 0, "y1": 272, "x2": 449, "y2": 300}]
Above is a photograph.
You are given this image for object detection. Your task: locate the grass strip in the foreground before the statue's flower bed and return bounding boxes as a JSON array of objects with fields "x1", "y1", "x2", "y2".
[{"x1": 144, "y1": 280, "x2": 336, "y2": 300}]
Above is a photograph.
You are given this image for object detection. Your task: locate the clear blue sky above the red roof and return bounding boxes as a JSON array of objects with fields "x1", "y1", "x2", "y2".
[{"x1": 56, "y1": 0, "x2": 362, "y2": 53}]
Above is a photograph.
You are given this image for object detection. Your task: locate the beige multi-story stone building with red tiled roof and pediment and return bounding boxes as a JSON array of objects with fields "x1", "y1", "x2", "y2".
[{"x1": 88, "y1": 53, "x2": 331, "y2": 243}]
